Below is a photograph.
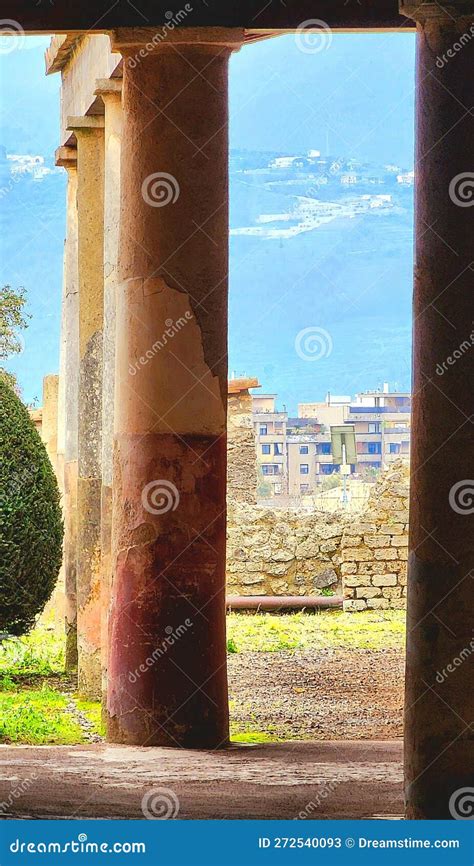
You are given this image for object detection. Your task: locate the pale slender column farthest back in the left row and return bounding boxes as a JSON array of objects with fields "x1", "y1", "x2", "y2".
[{"x1": 56, "y1": 147, "x2": 79, "y2": 671}]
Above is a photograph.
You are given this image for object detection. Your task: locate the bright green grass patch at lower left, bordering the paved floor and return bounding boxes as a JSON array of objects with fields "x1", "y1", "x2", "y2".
[{"x1": 0, "y1": 679, "x2": 84, "y2": 745}]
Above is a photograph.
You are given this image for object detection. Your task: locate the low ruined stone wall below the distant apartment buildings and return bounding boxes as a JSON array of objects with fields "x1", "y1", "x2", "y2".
[{"x1": 227, "y1": 461, "x2": 409, "y2": 611}]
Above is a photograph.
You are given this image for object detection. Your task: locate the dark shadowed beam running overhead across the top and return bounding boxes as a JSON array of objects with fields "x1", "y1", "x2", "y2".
[{"x1": 0, "y1": 0, "x2": 406, "y2": 35}]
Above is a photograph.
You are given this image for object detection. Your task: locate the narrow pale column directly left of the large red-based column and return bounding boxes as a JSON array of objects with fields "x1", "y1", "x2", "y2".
[{"x1": 95, "y1": 78, "x2": 122, "y2": 705}]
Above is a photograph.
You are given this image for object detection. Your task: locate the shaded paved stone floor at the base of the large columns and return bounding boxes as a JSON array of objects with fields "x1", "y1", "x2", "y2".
[{"x1": 0, "y1": 740, "x2": 403, "y2": 818}]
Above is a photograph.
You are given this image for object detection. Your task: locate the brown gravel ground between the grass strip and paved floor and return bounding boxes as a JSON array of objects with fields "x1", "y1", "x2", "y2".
[{"x1": 228, "y1": 649, "x2": 404, "y2": 740}]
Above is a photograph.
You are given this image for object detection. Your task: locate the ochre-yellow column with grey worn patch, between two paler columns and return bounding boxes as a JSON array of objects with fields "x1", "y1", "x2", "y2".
[{"x1": 68, "y1": 116, "x2": 104, "y2": 698}]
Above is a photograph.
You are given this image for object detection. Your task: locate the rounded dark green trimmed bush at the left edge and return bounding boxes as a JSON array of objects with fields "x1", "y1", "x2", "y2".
[{"x1": 0, "y1": 379, "x2": 63, "y2": 635}]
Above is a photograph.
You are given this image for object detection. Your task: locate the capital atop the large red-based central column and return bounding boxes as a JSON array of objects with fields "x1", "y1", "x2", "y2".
[{"x1": 109, "y1": 25, "x2": 245, "y2": 59}]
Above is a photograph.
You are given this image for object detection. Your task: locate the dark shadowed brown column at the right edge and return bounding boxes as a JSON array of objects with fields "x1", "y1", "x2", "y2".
[{"x1": 402, "y1": 0, "x2": 474, "y2": 819}]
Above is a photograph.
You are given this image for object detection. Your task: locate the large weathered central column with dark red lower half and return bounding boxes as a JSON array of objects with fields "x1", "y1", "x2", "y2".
[{"x1": 107, "y1": 29, "x2": 243, "y2": 748}]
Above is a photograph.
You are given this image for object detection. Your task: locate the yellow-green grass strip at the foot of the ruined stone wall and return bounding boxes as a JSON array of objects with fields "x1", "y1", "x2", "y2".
[{"x1": 227, "y1": 610, "x2": 405, "y2": 653}]
